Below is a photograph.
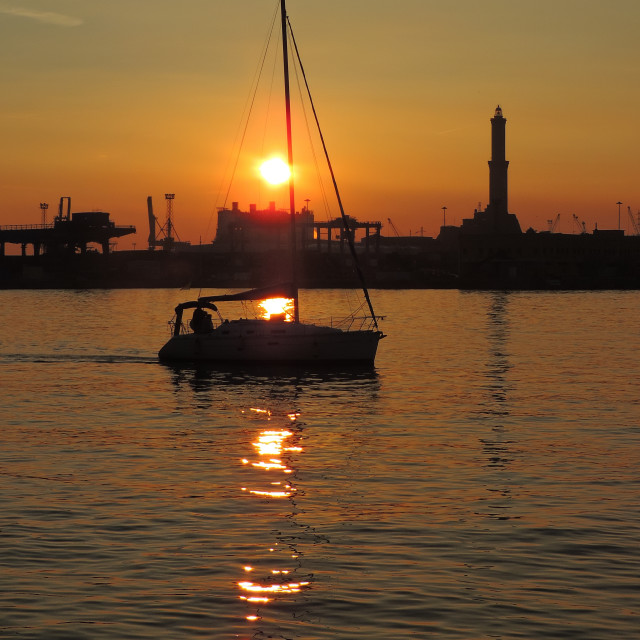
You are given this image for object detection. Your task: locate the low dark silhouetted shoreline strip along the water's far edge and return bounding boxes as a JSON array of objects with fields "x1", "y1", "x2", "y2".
[{"x1": 0, "y1": 234, "x2": 640, "y2": 291}]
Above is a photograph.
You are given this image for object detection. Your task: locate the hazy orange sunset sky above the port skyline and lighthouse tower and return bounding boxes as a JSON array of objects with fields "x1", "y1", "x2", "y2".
[{"x1": 0, "y1": 0, "x2": 640, "y2": 248}]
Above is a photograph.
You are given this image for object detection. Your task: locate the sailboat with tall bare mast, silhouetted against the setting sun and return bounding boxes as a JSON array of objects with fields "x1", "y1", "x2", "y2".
[{"x1": 158, "y1": 0, "x2": 385, "y2": 364}]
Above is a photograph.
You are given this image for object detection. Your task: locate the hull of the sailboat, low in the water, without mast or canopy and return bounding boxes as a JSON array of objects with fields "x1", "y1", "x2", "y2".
[{"x1": 158, "y1": 320, "x2": 382, "y2": 363}]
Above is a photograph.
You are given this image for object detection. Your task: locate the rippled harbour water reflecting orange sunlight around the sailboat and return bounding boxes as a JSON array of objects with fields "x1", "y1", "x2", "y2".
[{"x1": 0, "y1": 290, "x2": 640, "y2": 640}]
